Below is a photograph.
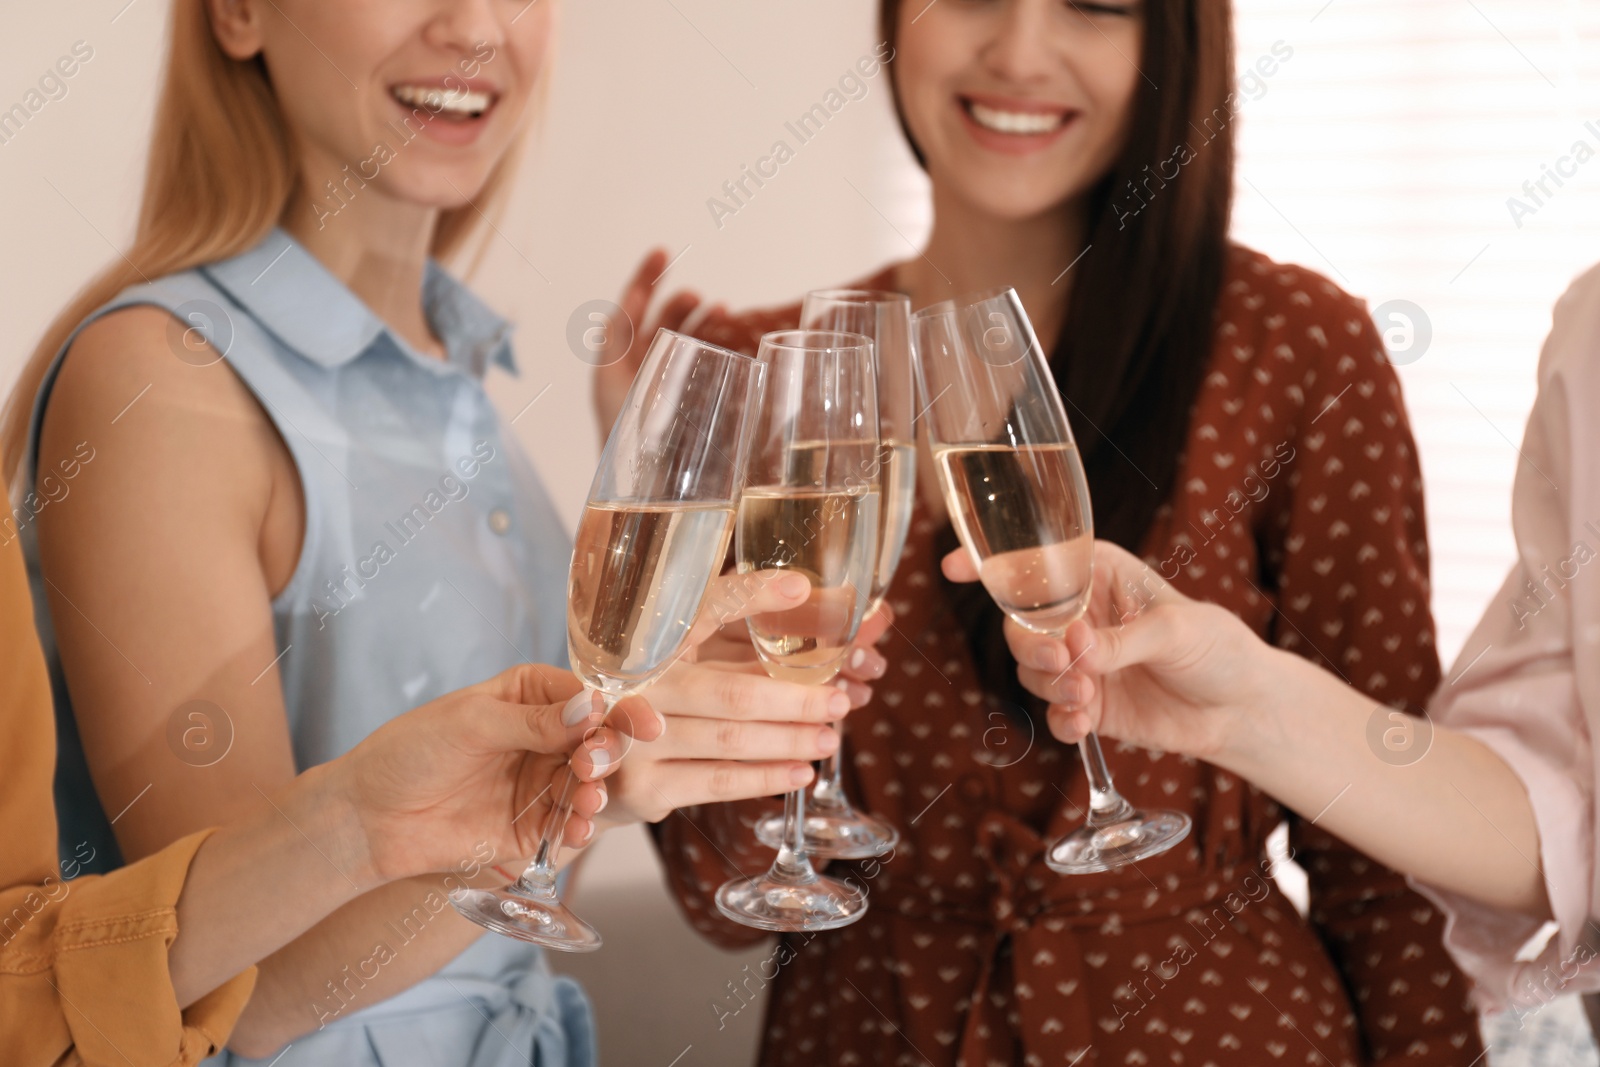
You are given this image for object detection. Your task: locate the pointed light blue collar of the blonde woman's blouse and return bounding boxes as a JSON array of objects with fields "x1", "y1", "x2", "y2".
[{"x1": 202, "y1": 227, "x2": 517, "y2": 378}]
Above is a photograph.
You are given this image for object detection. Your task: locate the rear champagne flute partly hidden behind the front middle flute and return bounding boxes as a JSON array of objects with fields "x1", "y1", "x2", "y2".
[{"x1": 755, "y1": 290, "x2": 917, "y2": 859}]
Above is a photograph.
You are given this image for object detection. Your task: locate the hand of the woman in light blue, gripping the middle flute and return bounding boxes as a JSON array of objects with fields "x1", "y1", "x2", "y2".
[{"x1": 600, "y1": 569, "x2": 888, "y2": 825}]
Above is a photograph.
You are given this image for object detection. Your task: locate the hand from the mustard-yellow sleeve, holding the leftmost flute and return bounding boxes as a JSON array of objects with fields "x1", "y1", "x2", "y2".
[{"x1": 328, "y1": 664, "x2": 661, "y2": 881}]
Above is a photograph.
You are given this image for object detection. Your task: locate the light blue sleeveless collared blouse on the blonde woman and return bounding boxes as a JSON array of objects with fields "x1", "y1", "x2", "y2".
[{"x1": 24, "y1": 230, "x2": 595, "y2": 1067}]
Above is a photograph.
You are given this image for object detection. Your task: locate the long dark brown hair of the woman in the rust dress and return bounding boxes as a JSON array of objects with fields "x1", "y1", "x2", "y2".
[{"x1": 878, "y1": 0, "x2": 1237, "y2": 707}]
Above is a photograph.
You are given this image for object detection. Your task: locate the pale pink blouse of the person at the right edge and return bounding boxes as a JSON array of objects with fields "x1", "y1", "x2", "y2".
[{"x1": 1418, "y1": 267, "x2": 1600, "y2": 1011}]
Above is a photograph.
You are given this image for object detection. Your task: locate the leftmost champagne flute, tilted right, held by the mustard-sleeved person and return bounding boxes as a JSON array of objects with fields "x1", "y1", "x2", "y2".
[{"x1": 450, "y1": 330, "x2": 763, "y2": 952}]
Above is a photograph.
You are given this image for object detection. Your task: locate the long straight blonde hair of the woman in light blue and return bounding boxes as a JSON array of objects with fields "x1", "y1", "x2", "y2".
[{"x1": 0, "y1": 0, "x2": 522, "y2": 485}]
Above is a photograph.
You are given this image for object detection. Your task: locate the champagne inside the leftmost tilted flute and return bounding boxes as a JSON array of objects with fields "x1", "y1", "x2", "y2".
[{"x1": 566, "y1": 502, "x2": 733, "y2": 696}]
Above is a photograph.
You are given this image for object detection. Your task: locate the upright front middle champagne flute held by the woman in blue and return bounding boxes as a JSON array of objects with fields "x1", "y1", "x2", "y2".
[{"x1": 717, "y1": 330, "x2": 880, "y2": 931}]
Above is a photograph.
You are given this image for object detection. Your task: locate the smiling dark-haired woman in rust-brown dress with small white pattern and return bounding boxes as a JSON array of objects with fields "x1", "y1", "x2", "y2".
[{"x1": 597, "y1": 0, "x2": 1480, "y2": 1067}]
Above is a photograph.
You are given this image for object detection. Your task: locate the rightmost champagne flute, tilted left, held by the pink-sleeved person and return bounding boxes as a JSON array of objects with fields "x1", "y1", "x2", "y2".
[{"x1": 912, "y1": 290, "x2": 1190, "y2": 873}]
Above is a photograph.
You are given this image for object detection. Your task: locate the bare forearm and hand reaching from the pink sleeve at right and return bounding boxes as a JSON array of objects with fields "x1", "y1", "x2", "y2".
[{"x1": 944, "y1": 542, "x2": 1549, "y2": 918}]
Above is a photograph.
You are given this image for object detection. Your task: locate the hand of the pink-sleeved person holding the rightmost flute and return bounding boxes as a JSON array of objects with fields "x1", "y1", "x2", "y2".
[{"x1": 942, "y1": 541, "x2": 1291, "y2": 760}]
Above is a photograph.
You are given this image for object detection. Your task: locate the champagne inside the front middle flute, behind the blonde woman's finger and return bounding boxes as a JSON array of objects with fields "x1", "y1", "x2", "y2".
[{"x1": 736, "y1": 486, "x2": 878, "y2": 683}]
